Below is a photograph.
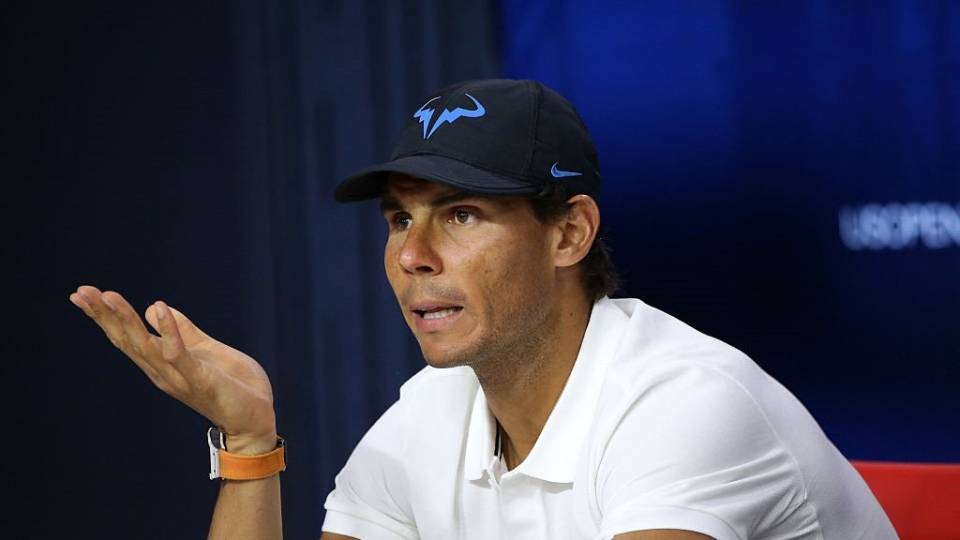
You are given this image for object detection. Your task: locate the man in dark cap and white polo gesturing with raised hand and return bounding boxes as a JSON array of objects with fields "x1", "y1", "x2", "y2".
[{"x1": 71, "y1": 80, "x2": 896, "y2": 540}]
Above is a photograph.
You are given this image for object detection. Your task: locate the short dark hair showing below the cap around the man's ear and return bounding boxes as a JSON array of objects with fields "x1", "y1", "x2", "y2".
[{"x1": 529, "y1": 189, "x2": 620, "y2": 302}]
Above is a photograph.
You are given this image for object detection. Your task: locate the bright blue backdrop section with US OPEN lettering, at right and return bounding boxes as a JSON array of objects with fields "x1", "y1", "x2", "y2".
[{"x1": 503, "y1": 0, "x2": 960, "y2": 461}]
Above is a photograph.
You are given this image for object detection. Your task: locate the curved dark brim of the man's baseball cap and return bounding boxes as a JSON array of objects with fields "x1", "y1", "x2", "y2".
[{"x1": 334, "y1": 154, "x2": 541, "y2": 202}]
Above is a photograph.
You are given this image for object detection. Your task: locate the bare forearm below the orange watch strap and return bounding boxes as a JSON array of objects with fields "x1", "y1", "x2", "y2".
[{"x1": 209, "y1": 474, "x2": 283, "y2": 540}]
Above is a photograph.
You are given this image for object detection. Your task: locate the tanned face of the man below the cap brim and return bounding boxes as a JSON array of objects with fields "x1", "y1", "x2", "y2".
[{"x1": 381, "y1": 175, "x2": 555, "y2": 367}]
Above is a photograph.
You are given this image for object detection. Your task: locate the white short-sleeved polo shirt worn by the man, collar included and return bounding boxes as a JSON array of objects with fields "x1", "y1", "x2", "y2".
[{"x1": 323, "y1": 298, "x2": 896, "y2": 540}]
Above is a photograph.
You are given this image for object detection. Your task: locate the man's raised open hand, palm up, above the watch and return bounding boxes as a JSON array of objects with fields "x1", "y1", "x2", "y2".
[{"x1": 70, "y1": 285, "x2": 276, "y2": 454}]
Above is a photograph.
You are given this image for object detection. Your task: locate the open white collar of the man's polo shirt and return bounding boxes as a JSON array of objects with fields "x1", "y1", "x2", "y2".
[{"x1": 464, "y1": 298, "x2": 629, "y2": 483}]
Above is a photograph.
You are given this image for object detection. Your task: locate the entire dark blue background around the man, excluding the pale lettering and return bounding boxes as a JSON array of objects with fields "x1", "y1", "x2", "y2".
[{"x1": 0, "y1": 0, "x2": 960, "y2": 538}]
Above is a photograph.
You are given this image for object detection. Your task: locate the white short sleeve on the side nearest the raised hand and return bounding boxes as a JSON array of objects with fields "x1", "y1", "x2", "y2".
[{"x1": 323, "y1": 402, "x2": 419, "y2": 540}]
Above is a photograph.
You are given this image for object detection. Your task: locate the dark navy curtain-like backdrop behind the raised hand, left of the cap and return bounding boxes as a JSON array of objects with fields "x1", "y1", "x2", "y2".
[{"x1": 11, "y1": 0, "x2": 499, "y2": 539}]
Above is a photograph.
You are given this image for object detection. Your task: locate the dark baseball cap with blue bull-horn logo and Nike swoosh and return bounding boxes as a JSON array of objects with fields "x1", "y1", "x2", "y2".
[{"x1": 335, "y1": 79, "x2": 600, "y2": 202}]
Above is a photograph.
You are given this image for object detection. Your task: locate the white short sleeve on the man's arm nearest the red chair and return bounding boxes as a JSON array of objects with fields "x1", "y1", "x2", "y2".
[{"x1": 596, "y1": 365, "x2": 804, "y2": 540}]
